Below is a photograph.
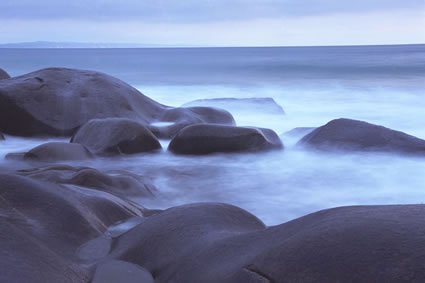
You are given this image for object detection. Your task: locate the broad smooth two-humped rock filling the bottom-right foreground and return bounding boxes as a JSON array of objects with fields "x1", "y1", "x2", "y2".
[{"x1": 108, "y1": 204, "x2": 425, "y2": 283}]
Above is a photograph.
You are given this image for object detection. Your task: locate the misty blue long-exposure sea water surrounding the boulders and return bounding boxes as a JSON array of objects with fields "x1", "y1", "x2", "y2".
[{"x1": 0, "y1": 45, "x2": 425, "y2": 225}]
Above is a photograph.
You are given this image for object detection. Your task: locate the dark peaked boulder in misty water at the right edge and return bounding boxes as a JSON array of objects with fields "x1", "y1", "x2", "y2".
[{"x1": 297, "y1": 119, "x2": 425, "y2": 155}]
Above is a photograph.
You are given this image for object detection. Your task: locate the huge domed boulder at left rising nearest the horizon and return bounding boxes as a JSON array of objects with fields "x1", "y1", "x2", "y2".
[{"x1": 0, "y1": 68, "x2": 164, "y2": 136}]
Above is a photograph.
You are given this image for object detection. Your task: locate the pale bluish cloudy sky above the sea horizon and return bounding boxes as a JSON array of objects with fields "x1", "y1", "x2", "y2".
[{"x1": 0, "y1": 0, "x2": 425, "y2": 46}]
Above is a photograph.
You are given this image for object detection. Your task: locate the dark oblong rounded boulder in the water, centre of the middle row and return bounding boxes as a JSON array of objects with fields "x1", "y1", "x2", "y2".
[{"x1": 168, "y1": 124, "x2": 283, "y2": 154}]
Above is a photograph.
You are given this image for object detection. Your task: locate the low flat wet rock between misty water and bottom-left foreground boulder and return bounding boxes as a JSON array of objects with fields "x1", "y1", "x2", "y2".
[{"x1": 17, "y1": 165, "x2": 158, "y2": 199}]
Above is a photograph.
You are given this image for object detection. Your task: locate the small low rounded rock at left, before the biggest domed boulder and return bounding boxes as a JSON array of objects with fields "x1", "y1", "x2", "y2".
[{"x1": 24, "y1": 142, "x2": 93, "y2": 161}]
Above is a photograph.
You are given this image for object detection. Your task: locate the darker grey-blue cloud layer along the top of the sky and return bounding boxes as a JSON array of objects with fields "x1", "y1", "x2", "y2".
[{"x1": 0, "y1": 0, "x2": 425, "y2": 23}]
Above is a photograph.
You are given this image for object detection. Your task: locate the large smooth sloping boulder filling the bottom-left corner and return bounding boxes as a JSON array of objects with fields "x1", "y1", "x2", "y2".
[{"x1": 0, "y1": 174, "x2": 142, "y2": 283}]
